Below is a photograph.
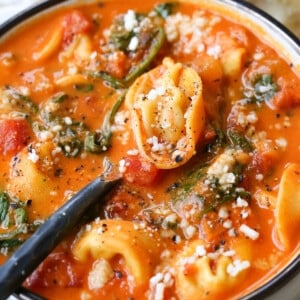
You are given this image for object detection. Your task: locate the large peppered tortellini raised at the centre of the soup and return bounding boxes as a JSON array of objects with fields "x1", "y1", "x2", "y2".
[{"x1": 125, "y1": 57, "x2": 205, "y2": 169}]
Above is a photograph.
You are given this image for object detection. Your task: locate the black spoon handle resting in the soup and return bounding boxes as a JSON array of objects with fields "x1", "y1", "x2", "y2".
[{"x1": 0, "y1": 177, "x2": 119, "y2": 300}]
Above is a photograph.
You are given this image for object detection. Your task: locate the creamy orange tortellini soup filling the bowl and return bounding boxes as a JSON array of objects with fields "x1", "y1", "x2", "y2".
[{"x1": 0, "y1": 0, "x2": 300, "y2": 300}]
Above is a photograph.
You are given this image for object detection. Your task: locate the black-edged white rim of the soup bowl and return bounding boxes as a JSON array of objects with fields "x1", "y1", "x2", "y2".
[{"x1": 0, "y1": 0, "x2": 300, "y2": 300}]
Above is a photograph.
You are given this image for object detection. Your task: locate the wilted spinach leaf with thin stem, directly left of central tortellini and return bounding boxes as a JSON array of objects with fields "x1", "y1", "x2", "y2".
[{"x1": 84, "y1": 92, "x2": 125, "y2": 153}]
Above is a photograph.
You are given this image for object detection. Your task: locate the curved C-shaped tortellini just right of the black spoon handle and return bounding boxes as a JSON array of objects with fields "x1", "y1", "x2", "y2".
[{"x1": 73, "y1": 220, "x2": 161, "y2": 287}]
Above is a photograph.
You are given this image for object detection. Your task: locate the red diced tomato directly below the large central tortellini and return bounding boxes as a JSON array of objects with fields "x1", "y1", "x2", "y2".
[{"x1": 124, "y1": 156, "x2": 159, "y2": 186}]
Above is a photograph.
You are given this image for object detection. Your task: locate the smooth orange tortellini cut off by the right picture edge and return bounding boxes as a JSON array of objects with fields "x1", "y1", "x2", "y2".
[{"x1": 275, "y1": 164, "x2": 300, "y2": 248}]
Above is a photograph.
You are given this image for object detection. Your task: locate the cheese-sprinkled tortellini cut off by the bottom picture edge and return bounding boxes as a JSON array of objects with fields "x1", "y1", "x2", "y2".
[{"x1": 175, "y1": 238, "x2": 252, "y2": 300}]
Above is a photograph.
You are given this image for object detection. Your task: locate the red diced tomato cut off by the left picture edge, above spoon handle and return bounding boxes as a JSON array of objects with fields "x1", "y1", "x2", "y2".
[{"x1": 0, "y1": 119, "x2": 32, "y2": 155}]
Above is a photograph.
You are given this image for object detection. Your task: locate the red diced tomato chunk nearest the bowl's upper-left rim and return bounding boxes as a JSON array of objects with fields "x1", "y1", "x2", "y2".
[{"x1": 62, "y1": 10, "x2": 93, "y2": 46}]
